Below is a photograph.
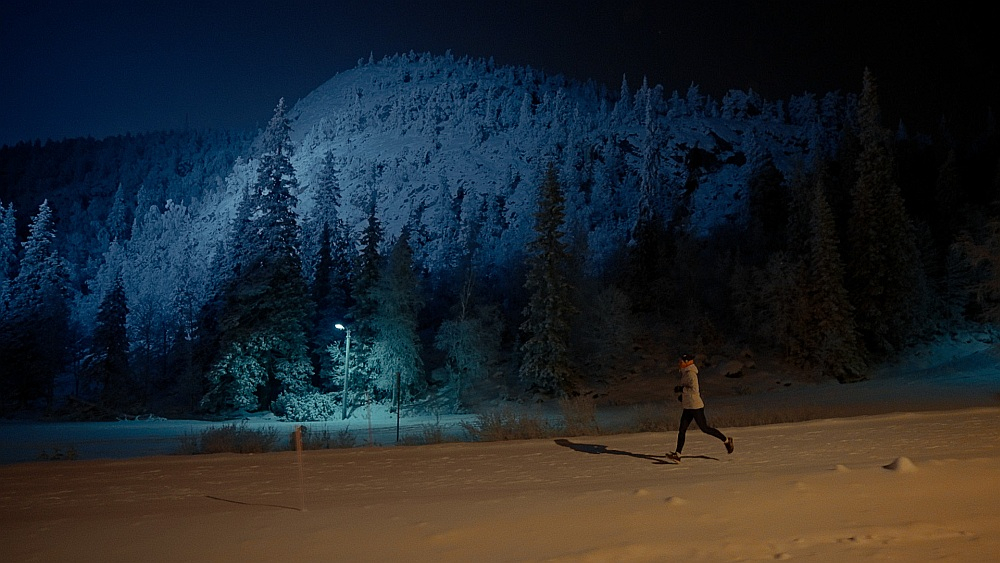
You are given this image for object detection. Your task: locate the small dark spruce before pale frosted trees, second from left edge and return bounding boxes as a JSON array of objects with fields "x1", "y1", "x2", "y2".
[{"x1": 84, "y1": 275, "x2": 135, "y2": 411}]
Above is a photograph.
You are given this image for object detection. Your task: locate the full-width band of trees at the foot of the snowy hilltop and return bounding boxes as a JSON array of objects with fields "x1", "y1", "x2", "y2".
[{"x1": 0, "y1": 65, "x2": 1000, "y2": 420}]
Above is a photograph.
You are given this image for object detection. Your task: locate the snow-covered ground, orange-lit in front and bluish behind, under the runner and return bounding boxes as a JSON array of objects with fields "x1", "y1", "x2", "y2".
[{"x1": 0, "y1": 338, "x2": 1000, "y2": 562}]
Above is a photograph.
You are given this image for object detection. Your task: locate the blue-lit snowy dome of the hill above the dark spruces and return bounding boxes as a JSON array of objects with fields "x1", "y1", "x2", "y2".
[{"x1": 282, "y1": 53, "x2": 850, "y2": 276}]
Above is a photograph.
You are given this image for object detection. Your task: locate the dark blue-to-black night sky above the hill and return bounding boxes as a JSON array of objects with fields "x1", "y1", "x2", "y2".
[{"x1": 0, "y1": 0, "x2": 1000, "y2": 144}]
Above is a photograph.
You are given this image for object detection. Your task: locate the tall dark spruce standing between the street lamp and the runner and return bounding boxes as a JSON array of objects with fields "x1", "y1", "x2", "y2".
[{"x1": 519, "y1": 166, "x2": 576, "y2": 396}]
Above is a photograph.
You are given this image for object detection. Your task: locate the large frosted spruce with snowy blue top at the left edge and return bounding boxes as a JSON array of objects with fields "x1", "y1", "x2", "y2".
[{"x1": 0, "y1": 200, "x2": 72, "y2": 405}]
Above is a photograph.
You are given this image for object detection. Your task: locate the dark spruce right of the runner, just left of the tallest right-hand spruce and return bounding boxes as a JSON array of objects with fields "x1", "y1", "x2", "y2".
[{"x1": 800, "y1": 178, "x2": 865, "y2": 383}]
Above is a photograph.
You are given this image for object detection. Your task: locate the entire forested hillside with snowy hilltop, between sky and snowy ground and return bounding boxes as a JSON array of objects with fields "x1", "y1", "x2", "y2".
[{"x1": 0, "y1": 53, "x2": 1000, "y2": 421}]
